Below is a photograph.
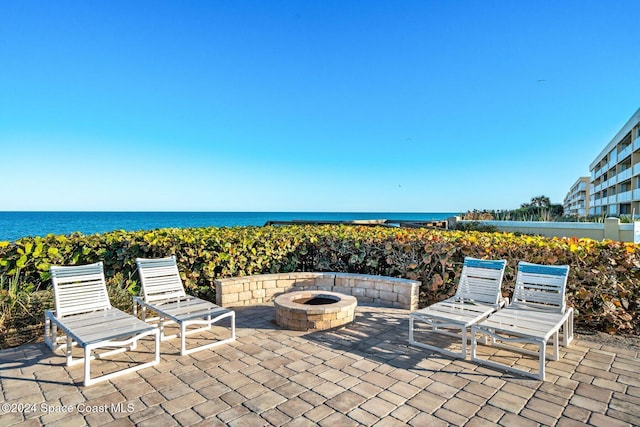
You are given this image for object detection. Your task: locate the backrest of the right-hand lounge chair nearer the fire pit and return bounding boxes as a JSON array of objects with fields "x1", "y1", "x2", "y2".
[{"x1": 455, "y1": 257, "x2": 507, "y2": 305}]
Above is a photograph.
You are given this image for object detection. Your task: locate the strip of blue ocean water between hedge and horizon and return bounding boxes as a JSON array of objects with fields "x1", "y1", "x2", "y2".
[{"x1": 0, "y1": 212, "x2": 458, "y2": 241}]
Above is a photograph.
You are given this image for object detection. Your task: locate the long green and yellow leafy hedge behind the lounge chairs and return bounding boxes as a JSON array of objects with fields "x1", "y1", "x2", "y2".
[{"x1": 0, "y1": 225, "x2": 640, "y2": 350}]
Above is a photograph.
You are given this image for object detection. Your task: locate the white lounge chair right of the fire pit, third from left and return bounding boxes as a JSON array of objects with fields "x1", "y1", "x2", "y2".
[{"x1": 409, "y1": 257, "x2": 507, "y2": 359}]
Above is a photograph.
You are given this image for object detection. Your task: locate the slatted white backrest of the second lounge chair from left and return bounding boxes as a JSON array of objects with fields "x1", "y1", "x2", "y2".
[{"x1": 136, "y1": 256, "x2": 186, "y2": 302}]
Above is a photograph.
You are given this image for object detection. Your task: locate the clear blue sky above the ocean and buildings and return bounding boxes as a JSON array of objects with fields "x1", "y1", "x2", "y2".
[{"x1": 0, "y1": 0, "x2": 640, "y2": 212}]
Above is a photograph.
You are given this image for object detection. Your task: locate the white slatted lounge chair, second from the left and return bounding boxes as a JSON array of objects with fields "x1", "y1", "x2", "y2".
[{"x1": 133, "y1": 256, "x2": 236, "y2": 356}]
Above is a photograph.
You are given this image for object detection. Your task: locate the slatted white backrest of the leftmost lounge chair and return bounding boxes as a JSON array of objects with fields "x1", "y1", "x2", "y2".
[{"x1": 49, "y1": 262, "x2": 111, "y2": 317}]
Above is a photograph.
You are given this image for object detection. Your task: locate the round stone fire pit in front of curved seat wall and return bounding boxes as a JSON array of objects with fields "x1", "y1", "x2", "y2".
[{"x1": 274, "y1": 290, "x2": 358, "y2": 331}]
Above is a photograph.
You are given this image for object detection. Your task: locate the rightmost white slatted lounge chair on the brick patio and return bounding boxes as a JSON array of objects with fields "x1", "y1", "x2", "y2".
[{"x1": 471, "y1": 262, "x2": 573, "y2": 381}]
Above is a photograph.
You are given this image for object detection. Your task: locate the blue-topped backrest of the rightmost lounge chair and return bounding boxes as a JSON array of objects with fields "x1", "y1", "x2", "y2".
[{"x1": 512, "y1": 261, "x2": 569, "y2": 313}]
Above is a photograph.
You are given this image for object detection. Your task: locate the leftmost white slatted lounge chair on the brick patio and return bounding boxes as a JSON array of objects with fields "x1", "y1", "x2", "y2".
[{"x1": 44, "y1": 262, "x2": 160, "y2": 386}]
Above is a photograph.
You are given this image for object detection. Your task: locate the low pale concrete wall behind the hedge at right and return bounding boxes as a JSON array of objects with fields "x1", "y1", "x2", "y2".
[{"x1": 449, "y1": 217, "x2": 640, "y2": 242}]
